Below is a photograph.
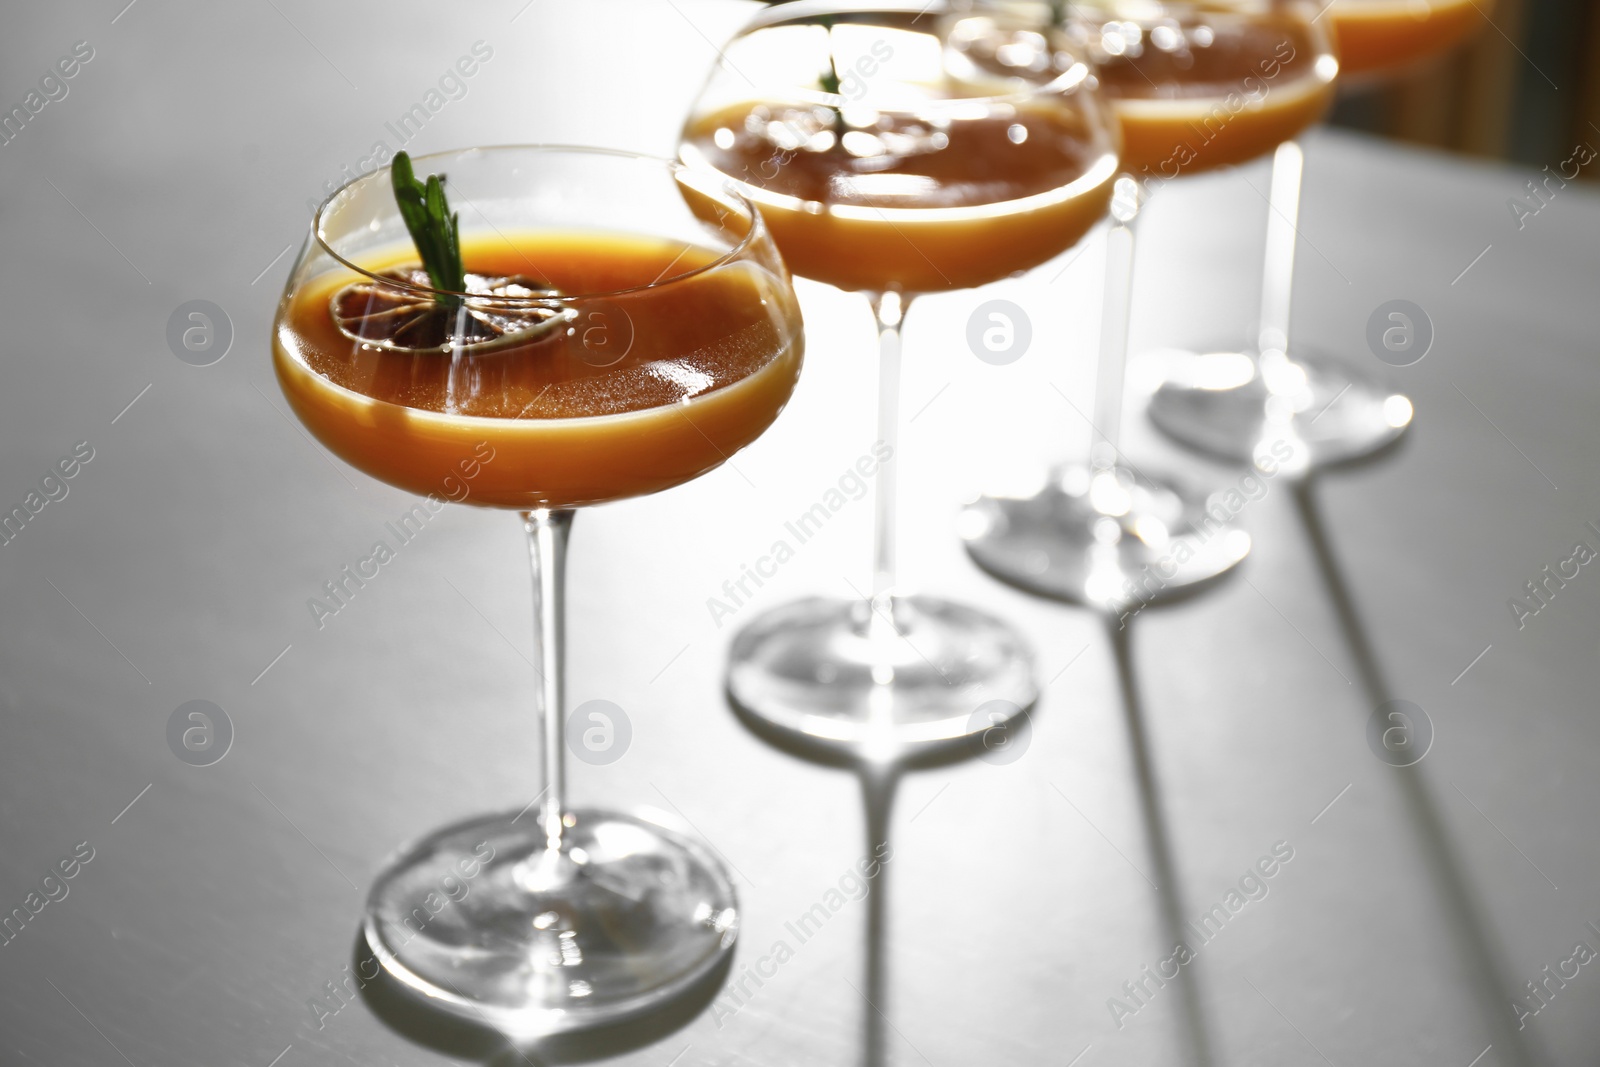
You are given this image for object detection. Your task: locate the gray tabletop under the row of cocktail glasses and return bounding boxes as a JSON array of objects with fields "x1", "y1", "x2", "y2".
[{"x1": 0, "y1": 0, "x2": 1600, "y2": 1067}]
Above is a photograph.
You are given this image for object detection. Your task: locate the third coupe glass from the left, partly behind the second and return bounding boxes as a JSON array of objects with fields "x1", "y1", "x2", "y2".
[{"x1": 962, "y1": 0, "x2": 1338, "y2": 614}]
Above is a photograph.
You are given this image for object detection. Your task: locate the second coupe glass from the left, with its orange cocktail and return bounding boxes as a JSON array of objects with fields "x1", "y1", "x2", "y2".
[{"x1": 682, "y1": 0, "x2": 1117, "y2": 755}]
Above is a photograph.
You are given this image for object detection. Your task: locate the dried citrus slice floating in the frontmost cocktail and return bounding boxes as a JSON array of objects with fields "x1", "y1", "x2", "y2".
[{"x1": 330, "y1": 267, "x2": 573, "y2": 352}]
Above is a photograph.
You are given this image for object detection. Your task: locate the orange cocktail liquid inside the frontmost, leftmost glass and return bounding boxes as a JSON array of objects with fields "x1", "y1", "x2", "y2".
[{"x1": 274, "y1": 232, "x2": 802, "y2": 509}]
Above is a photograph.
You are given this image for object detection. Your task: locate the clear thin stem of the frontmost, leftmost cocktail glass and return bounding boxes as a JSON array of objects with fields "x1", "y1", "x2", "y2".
[{"x1": 522, "y1": 509, "x2": 573, "y2": 853}]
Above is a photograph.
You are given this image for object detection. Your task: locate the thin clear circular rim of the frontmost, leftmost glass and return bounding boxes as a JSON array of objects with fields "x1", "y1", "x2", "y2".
[{"x1": 310, "y1": 144, "x2": 766, "y2": 307}]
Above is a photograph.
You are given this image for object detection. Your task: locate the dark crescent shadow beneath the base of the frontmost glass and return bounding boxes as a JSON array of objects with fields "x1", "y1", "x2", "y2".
[{"x1": 352, "y1": 931, "x2": 733, "y2": 1067}]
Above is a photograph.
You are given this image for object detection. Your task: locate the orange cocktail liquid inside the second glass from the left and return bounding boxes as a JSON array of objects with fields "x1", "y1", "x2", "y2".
[{"x1": 682, "y1": 96, "x2": 1115, "y2": 293}]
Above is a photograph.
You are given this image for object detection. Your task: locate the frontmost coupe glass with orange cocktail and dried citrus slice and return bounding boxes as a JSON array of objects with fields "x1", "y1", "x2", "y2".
[{"x1": 274, "y1": 147, "x2": 802, "y2": 1035}]
